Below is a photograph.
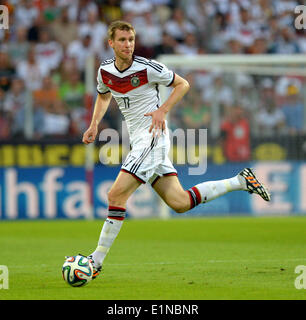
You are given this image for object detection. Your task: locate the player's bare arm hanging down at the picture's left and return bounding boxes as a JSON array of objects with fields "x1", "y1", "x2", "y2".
[{"x1": 82, "y1": 92, "x2": 112, "y2": 144}]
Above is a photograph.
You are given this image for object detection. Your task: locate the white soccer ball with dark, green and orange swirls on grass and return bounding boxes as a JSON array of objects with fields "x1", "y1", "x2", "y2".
[{"x1": 62, "y1": 255, "x2": 93, "y2": 287}]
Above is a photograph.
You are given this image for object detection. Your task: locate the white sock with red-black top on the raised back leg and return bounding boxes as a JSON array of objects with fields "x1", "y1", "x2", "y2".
[{"x1": 188, "y1": 176, "x2": 244, "y2": 205}]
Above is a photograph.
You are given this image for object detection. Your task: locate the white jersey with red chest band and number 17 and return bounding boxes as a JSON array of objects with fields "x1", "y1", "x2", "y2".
[{"x1": 97, "y1": 56, "x2": 175, "y2": 144}]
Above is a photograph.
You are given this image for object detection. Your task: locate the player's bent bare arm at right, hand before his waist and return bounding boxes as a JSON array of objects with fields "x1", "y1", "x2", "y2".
[{"x1": 145, "y1": 74, "x2": 190, "y2": 132}]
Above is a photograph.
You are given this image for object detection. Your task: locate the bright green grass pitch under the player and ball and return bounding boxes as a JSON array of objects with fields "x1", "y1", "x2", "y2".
[{"x1": 0, "y1": 217, "x2": 306, "y2": 300}]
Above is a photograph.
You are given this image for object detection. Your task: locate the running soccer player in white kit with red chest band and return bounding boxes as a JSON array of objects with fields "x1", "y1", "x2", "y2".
[{"x1": 83, "y1": 21, "x2": 270, "y2": 278}]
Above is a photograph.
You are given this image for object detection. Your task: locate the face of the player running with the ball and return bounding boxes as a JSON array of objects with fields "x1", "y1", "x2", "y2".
[{"x1": 109, "y1": 30, "x2": 135, "y2": 60}]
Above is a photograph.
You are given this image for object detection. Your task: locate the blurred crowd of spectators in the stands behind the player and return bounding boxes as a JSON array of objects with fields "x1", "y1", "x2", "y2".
[{"x1": 0, "y1": 0, "x2": 306, "y2": 159}]
